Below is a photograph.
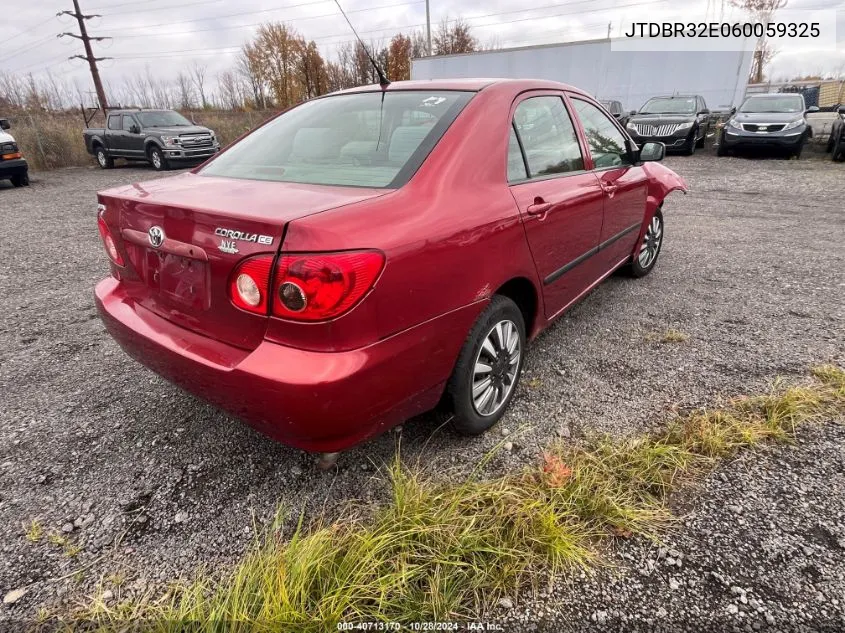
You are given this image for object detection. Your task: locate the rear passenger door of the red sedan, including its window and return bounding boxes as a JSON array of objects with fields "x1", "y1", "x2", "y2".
[{"x1": 508, "y1": 92, "x2": 604, "y2": 318}]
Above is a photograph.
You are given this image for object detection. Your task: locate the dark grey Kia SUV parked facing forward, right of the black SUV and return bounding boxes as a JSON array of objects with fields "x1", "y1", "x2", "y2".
[{"x1": 716, "y1": 93, "x2": 818, "y2": 158}]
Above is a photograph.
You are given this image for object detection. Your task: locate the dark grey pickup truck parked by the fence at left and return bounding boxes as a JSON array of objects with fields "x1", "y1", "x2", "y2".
[{"x1": 82, "y1": 110, "x2": 220, "y2": 171}]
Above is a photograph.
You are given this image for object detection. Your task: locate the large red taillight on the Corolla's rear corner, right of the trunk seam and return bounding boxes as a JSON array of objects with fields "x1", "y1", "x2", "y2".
[{"x1": 273, "y1": 251, "x2": 384, "y2": 321}]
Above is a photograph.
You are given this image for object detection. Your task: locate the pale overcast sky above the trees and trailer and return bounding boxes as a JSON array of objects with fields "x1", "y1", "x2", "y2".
[{"x1": 0, "y1": 0, "x2": 845, "y2": 101}]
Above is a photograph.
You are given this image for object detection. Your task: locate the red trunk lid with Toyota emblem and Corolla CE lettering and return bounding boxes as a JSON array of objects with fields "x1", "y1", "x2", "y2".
[{"x1": 99, "y1": 174, "x2": 386, "y2": 349}]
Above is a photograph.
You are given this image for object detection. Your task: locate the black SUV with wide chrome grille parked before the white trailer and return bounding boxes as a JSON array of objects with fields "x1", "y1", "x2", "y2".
[{"x1": 627, "y1": 95, "x2": 710, "y2": 156}]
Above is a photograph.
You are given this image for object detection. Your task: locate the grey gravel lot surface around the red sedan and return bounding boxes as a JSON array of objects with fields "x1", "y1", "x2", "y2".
[{"x1": 0, "y1": 153, "x2": 845, "y2": 631}]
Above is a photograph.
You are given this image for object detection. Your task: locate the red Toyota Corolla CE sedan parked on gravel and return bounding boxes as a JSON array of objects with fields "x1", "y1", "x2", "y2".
[{"x1": 96, "y1": 79, "x2": 686, "y2": 452}]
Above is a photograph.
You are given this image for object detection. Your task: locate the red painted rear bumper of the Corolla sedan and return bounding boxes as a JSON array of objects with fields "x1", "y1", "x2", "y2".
[{"x1": 95, "y1": 278, "x2": 484, "y2": 452}]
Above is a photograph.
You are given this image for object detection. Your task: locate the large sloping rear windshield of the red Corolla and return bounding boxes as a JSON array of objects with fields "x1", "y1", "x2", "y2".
[{"x1": 199, "y1": 90, "x2": 473, "y2": 188}]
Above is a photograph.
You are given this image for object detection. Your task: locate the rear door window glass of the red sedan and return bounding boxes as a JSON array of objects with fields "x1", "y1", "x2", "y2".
[{"x1": 513, "y1": 96, "x2": 584, "y2": 178}]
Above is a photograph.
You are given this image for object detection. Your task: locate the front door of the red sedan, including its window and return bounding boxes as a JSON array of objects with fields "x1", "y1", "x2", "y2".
[{"x1": 568, "y1": 94, "x2": 648, "y2": 272}]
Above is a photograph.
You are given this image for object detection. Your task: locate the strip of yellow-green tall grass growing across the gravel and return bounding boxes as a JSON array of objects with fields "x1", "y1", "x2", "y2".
[{"x1": 62, "y1": 366, "x2": 845, "y2": 633}]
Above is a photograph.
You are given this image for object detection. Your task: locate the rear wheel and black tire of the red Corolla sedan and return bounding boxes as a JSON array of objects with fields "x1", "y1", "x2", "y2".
[{"x1": 445, "y1": 295, "x2": 525, "y2": 435}]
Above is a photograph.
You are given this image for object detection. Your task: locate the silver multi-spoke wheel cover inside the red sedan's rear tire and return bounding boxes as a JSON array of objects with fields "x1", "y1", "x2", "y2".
[{"x1": 472, "y1": 319, "x2": 522, "y2": 417}]
